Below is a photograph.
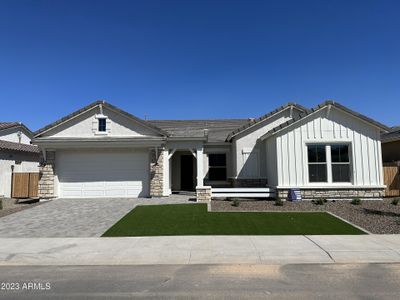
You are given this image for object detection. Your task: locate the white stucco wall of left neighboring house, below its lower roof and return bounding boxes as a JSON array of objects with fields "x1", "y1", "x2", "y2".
[{"x1": 0, "y1": 152, "x2": 39, "y2": 197}]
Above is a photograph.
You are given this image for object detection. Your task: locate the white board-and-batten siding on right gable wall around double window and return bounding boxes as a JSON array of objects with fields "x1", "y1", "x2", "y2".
[{"x1": 265, "y1": 107, "x2": 383, "y2": 188}]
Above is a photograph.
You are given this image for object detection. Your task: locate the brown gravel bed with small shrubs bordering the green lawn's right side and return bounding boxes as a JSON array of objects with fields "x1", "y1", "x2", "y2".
[{"x1": 211, "y1": 199, "x2": 400, "y2": 234}]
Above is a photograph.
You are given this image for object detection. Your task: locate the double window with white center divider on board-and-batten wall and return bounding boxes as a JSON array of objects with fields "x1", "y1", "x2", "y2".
[{"x1": 307, "y1": 144, "x2": 351, "y2": 182}]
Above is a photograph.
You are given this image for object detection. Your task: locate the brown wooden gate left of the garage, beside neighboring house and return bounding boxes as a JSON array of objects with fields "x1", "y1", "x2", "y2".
[{"x1": 11, "y1": 173, "x2": 39, "y2": 198}]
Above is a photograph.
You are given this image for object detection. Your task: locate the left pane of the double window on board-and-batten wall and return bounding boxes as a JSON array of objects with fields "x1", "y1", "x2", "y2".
[{"x1": 308, "y1": 145, "x2": 328, "y2": 182}]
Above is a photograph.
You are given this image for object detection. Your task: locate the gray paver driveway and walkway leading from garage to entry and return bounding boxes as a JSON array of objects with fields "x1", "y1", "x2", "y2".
[{"x1": 0, "y1": 195, "x2": 193, "y2": 238}]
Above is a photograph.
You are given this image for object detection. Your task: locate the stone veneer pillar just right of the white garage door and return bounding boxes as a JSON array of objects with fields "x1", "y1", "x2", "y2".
[{"x1": 150, "y1": 149, "x2": 164, "y2": 197}]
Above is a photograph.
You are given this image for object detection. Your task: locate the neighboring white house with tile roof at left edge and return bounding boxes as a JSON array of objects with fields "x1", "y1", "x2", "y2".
[{"x1": 0, "y1": 122, "x2": 39, "y2": 197}]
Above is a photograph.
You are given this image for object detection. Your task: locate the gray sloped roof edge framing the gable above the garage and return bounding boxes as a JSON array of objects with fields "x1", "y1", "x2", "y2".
[{"x1": 34, "y1": 100, "x2": 168, "y2": 137}]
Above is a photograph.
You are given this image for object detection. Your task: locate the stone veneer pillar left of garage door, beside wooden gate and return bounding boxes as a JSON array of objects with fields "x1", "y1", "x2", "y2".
[{"x1": 39, "y1": 151, "x2": 56, "y2": 198}]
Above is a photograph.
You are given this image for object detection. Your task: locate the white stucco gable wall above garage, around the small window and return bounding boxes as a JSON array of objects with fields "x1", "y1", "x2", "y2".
[{"x1": 43, "y1": 106, "x2": 157, "y2": 138}]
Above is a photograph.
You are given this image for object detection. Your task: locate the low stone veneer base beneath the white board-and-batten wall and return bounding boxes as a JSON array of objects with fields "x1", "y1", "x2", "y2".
[{"x1": 277, "y1": 188, "x2": 385, "y2": 200}]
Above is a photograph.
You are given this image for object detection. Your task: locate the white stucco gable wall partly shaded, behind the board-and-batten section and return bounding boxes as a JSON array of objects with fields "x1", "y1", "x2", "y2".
[{"x1": 232, "y1": 108, "x2": 300, "y2": 178}]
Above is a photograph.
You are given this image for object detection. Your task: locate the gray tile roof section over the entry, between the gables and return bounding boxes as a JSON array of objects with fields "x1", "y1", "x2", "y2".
[{"x1": 147, "y1": 119, "x2": 249, "y2": 142}]
